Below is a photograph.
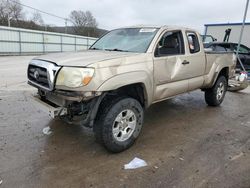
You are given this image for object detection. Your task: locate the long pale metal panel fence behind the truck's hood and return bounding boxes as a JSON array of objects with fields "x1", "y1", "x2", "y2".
[{"x1": 0, "y1": 26, "x2": 96, "y2": 55}]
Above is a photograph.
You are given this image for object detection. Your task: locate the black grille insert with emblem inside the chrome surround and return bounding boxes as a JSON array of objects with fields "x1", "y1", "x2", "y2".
[{"x1": 28, "y1": 65, "x2": 50, "y2": 88}]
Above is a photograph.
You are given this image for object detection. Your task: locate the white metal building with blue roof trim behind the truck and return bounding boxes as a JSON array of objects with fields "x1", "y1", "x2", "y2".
[{"x1": 204, "y1": 22, "x2": 250, "y2": 47}]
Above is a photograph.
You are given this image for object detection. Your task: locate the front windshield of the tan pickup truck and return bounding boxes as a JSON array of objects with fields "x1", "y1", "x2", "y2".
[{"x1": 90, "y1": 28, "x2": 158, "y2": 53}]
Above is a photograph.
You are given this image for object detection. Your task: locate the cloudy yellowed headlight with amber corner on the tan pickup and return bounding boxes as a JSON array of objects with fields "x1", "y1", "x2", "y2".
[{"x1": 56, "y1": 67, "x2": 95, "y2": 87}]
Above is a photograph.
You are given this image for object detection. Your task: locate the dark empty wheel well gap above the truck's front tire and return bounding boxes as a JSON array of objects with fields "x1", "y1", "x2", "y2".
[{"x1": 101, "y1": 83, "x2": 147, "y2": 108}]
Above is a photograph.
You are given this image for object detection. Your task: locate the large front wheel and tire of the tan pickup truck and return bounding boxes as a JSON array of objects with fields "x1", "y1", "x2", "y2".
[{"x1": 93, "y1": 97, "x2": 144, "y2": 153}]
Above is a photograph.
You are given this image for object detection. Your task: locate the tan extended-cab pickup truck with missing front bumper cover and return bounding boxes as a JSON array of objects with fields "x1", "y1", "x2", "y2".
[{"x1": 27, "y1": 26, "x2": 236, "y2": 152}]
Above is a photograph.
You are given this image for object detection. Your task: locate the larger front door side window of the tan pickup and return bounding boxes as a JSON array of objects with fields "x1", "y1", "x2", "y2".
[{"x1": 155, "y1": 31, "x2": 184, "y2": 57}]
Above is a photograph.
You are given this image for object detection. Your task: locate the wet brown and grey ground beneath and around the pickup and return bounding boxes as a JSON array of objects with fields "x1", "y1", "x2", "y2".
[{"x1": 0, "y1": 56, "x2": 250, "y2": 188}]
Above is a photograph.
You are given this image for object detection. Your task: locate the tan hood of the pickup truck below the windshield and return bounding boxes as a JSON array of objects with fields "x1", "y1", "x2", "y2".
[{"x1": 35, "y1": 50, "x2": 139, "y2": 67}]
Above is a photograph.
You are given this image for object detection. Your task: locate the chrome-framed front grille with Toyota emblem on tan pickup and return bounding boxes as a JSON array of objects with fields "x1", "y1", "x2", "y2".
[{"x1": 27, "y1": 60, "x2": 60, "y2": 91}]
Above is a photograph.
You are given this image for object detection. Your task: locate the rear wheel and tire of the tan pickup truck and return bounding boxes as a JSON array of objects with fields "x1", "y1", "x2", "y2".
[{"x1": 205, "y1": 76, "x2": 228, "y2": 106}]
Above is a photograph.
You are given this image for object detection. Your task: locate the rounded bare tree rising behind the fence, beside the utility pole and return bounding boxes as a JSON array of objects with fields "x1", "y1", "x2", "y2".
[{"x1": 69, "y1": 10, "x2": 98, "y2": 36}]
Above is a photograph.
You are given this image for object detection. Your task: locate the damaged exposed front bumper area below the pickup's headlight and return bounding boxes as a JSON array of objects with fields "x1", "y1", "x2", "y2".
[{"x1": 32, "y1": 89, "x2": 105, "y2": 127}]
